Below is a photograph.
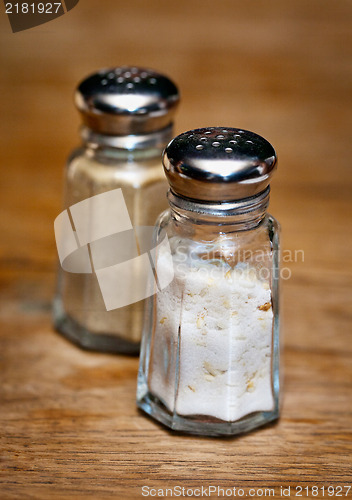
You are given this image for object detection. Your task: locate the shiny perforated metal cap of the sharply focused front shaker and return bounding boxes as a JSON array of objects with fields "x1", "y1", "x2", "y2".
[{"x1": 163, "y1": 127, "x2": 277, "y2": 202}]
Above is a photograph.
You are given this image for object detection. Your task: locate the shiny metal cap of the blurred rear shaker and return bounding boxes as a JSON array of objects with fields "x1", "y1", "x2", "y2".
[{"x1": 75, "y1": 66, "x2": 179, "y2": 135}]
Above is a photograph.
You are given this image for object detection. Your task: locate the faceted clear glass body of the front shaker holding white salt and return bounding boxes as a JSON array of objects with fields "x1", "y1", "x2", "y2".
[{"x1": 137, "y1": 206, "x2": 279, "y2": 436}]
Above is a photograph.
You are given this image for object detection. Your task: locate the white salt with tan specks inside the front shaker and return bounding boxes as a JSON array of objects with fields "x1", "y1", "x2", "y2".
[{"x1": 149, "y1": 249, "x2": 274, "y2": 421}]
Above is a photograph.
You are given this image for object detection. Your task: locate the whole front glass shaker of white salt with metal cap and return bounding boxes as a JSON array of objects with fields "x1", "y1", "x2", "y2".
[{"x1": 137, "y1": 127, "x2": 279, "y2": 436}]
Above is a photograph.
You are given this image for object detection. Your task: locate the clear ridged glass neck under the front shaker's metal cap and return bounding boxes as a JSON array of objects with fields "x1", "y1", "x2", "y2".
[{"x1": 167, "y1": 186, "x2": 270, "y2": 232}]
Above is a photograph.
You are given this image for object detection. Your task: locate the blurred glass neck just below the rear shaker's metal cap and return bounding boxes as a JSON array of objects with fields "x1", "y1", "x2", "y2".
[{"x1": 80, "y1": 123, "x2": 173, "y2": 154}]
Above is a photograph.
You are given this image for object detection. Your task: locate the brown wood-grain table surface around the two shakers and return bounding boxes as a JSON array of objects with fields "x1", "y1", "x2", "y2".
[{"x1": 0, "y1": 0, "x2": 352, "y2": 500}]
